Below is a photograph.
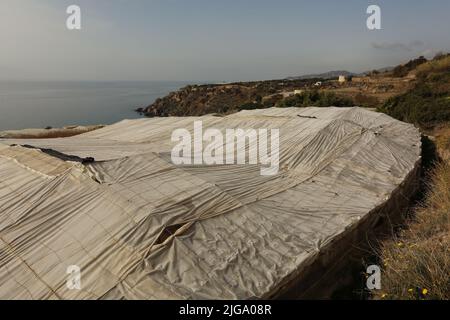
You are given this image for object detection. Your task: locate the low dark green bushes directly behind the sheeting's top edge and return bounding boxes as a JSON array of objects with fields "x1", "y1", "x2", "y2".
[{"x1": 277, "y1": 90, "x2": 355, "y2": 108}]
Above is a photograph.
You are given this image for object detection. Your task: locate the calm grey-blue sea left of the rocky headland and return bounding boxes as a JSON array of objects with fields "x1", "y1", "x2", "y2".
[{"x1": 0, "y1": 81, "x2": 188, "y2": 131}]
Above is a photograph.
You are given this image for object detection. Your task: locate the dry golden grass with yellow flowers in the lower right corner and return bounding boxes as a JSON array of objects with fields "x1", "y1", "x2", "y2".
[{"x1": 374, "y1": 145, "x2": 450, "y2": 300}]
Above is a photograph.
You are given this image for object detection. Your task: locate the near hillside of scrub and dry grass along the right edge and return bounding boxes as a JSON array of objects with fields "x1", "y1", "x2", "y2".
[{"x1": 375, "y1": 55, "x2": 450, "y2": 300}]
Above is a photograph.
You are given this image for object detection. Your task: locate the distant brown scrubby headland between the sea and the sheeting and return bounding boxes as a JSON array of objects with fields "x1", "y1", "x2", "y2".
[{"x1": 141, "y1": 59, "x2": 415, "y2": 117}]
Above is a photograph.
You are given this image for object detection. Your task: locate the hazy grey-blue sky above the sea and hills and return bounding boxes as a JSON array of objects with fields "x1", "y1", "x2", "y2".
[{"x1": 0, "y1": 0, "x2": 450, "y2": 81}]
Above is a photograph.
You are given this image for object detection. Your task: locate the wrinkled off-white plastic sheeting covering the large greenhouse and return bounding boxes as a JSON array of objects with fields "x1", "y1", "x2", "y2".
[{"x1": 0, "y1": 108, "x2": 421, "y2": 299}]
